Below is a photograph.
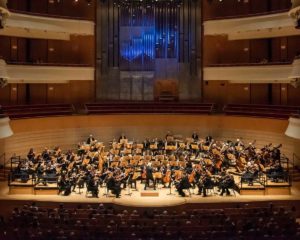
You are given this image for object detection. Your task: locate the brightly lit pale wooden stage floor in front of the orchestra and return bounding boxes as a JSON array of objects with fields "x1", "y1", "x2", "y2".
[{"x1": 0, "y1": 182, "x2": 300, "y2": 207}]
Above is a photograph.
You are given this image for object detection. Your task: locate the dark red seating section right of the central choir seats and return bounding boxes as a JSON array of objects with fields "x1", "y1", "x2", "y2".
[{"x1": 223, "y1": 104, "x2": 300, "y2": 119}]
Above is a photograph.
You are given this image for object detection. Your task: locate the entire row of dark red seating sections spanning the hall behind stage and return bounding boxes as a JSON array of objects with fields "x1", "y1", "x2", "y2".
[{"x1": 0, "y1": 101, "x2": 300, "y2": 120}]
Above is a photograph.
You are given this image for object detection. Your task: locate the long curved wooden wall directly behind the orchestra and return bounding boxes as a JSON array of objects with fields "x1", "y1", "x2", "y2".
[{"x1": 5, "y1": 114, "x2": 294, "y2": 163}]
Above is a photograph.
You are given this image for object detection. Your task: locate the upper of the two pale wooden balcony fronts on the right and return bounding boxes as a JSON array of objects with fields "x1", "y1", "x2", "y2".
[{"x1": 204, "y1": 11, "x2": 300, "y2": 40}]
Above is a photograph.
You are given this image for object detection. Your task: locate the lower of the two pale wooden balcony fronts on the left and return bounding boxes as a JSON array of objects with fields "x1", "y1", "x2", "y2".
[{"x1": 6, "y1": 62, "x2": 95, "y2": 83}]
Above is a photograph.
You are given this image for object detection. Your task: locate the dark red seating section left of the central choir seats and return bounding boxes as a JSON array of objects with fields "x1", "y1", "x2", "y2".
[{"x1": 0, "y1": 104, "x2": 74, "y2": 119}]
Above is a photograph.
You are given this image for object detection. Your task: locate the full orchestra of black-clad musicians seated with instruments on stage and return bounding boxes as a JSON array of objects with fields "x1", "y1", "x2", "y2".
[{"x1": 10, "y1": 132, "x2": 286, "y2": 198}]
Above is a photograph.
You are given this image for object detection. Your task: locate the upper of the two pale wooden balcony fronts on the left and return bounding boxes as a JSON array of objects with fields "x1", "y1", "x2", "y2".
[{"x1": 0, "y1": 11, "x2": 95, "y2": 40}]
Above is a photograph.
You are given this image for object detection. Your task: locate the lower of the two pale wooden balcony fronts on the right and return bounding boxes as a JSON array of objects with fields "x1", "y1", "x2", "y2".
[{"x1": 203, "y1": 62, "x2": 293, "y2": 83}]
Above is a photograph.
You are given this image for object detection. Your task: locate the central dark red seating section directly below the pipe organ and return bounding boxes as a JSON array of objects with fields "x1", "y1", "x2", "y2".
[{"x1": 85, "y1": 101, "x2": 215, "y2": 114}]
